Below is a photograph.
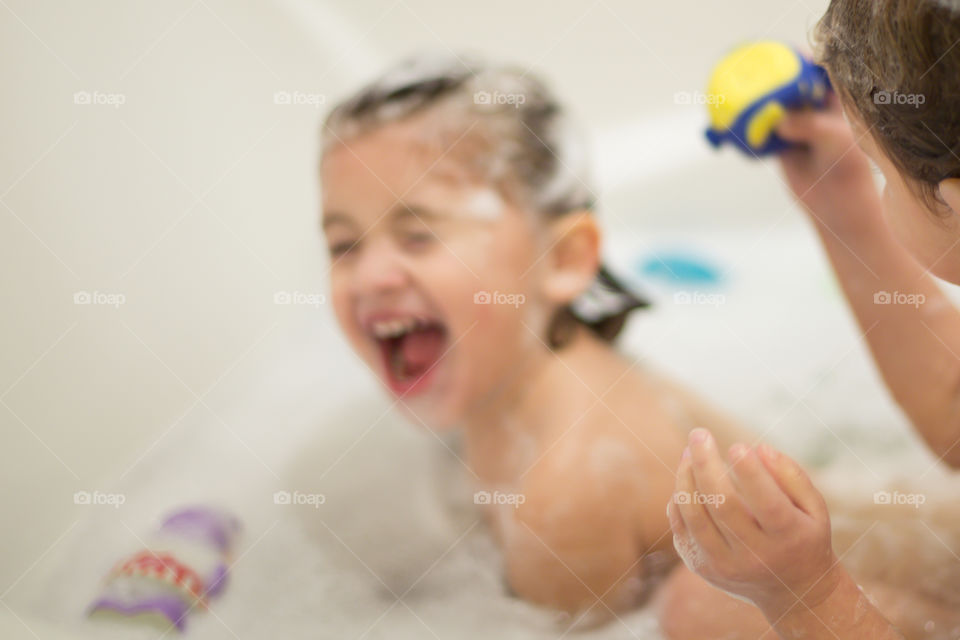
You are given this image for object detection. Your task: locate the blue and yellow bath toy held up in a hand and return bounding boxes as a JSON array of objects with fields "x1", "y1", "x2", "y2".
[{"x1": 707, "y1": 41, "x2": 830, "y2": 156}]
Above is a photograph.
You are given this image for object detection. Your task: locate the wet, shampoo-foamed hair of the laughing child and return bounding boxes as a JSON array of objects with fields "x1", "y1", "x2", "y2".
[{"x1": 321, "y1": 53, "x2": 647, "y2": 348}]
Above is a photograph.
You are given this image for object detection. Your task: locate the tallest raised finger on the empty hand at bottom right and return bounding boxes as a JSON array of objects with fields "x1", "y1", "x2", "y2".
[{"x1": 690, "y1": 429, "x2": 756, "y2": 546}]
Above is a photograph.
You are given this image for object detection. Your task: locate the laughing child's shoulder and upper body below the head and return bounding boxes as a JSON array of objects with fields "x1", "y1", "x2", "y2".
[{"x1": 467, "y1": 324, "x2": 743, "y2": 617}]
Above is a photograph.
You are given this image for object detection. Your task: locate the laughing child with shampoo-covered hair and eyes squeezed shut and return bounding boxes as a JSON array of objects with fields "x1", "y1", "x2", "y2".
[{"x1": 320, "y1": 56, "x2": 752, "y2": 618}]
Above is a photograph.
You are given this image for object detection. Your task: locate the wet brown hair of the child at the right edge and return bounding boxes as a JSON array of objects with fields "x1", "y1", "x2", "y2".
[{"x1": 814, "y1": 0, "x2": 960, "y2": 209}]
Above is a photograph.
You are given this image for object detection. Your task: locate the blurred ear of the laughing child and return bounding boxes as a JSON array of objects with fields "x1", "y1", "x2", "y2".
[{"x1": 544, "y1": 211, "x2": 600, "y2": 305}]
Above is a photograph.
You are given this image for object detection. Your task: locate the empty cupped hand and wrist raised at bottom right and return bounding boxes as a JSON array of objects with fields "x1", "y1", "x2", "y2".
[{"x1": 668, "y1": 429, "x2": 903, "y2": 640}]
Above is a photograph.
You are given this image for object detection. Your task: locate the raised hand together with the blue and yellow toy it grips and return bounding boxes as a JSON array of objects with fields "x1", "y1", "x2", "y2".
[{"x1": 707, "y1": 42, "x2": 880, "y2": 229}]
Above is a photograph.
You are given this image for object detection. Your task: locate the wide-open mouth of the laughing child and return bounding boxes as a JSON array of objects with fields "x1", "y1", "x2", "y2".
[{"x1": 371, "y1": 317, "x2": 447, "y2": 395}]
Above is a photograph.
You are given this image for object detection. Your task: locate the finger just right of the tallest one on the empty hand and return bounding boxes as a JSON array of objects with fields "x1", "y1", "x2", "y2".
[{"x1": 730, "y1": 444, "x2": 796, "y2": 532}]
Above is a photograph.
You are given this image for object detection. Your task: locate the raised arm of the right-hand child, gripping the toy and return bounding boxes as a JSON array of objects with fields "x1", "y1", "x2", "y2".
[{"x1": 780, "y1": 96, "x2": 960, "y2": 467}]
